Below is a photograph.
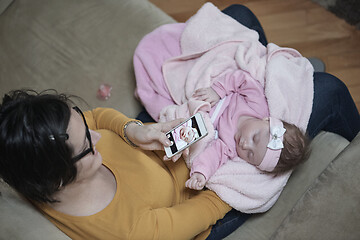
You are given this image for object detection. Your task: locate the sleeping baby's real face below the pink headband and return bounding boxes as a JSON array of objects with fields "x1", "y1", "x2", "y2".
[{"x1": 235, "y1": 116, "x2": 270, "y2": 166}]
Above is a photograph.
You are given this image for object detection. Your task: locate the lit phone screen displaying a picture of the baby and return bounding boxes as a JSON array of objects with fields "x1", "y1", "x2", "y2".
[{"x1": 167, "y1": 116, "x2": 202, "y2": 154}]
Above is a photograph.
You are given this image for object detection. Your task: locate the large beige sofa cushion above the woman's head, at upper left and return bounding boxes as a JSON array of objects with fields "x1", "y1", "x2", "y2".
[{"x1": 0, "y1": 0, "x2": 174, "y2": 117}]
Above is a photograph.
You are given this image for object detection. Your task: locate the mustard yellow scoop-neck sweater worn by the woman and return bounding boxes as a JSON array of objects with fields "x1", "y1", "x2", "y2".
[{"x1": 40, "y1": 108, "x2": 230, "y2": 240}]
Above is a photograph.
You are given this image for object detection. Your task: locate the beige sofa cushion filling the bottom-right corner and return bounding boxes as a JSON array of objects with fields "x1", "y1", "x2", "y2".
[{"x1": 273, "y1": 133, "x2": 360, "y2": 240}]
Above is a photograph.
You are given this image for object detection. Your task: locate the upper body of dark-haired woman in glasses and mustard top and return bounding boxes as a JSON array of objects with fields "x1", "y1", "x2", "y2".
[{"x1": 0, "y1": 91, "x2": 230, "y2": 239}]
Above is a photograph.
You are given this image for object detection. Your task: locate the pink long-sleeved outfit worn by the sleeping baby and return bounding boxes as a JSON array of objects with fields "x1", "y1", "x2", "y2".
[{"x1": 190, "y1": 70, "x2": 269, "y2": 180}]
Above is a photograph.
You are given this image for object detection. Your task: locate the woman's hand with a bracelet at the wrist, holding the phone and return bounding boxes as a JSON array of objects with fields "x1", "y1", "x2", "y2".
[{"x1": 126, "y1": 119, "x2": 188, "y2": 162}]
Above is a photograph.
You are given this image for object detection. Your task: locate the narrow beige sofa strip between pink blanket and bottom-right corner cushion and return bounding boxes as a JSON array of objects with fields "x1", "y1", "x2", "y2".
[{"x1": 226, "y1": 132, "x2": 349, "y2": 240}]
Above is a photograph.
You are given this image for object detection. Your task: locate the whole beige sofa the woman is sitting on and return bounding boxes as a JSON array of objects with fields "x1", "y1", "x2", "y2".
[{"x1": 0, "y1": 0, "x2": 360, "y2": 240}]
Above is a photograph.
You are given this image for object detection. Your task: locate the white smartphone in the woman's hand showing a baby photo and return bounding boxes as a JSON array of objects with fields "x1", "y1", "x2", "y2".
[{"x1": 164, "y1": 113, "x2": 208, "y2": 158}]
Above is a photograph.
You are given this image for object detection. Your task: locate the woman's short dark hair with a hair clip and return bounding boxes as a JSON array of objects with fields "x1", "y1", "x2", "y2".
[{"x1": 0, "y1": 90, "x2": 77, "y2": 202}]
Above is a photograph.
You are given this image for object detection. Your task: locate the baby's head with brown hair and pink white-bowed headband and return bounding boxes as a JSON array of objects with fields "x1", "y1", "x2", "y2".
[{"x1": 235, "y1": 117, "x2": 309, "y2": 173}]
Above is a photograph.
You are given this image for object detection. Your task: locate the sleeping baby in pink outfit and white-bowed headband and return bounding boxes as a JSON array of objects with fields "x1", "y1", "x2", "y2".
[{"x1": 185, "y1": 73, "x2": 308, "y2": 190}]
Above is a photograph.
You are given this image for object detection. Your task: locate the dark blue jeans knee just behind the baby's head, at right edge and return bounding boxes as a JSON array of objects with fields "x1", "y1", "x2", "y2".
[{"x1": 307, "y1": 72, "x2": 360, "y2": 141}]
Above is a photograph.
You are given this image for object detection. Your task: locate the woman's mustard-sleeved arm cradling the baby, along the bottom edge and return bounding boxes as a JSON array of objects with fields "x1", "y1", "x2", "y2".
[{"x1": 129, "y1": 190, "x2": 231, "y2": 239}]
